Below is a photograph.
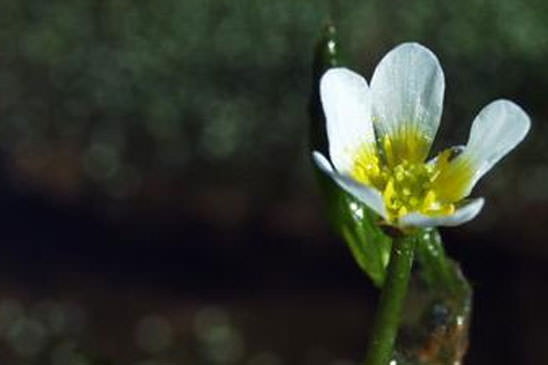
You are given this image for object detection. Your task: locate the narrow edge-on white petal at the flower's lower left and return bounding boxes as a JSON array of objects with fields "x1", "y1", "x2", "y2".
[{"x1": 312, "y1": 151, "x2": 387, "y2": 218}]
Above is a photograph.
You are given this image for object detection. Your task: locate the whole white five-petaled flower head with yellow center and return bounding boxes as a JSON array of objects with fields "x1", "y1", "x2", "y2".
[{"x1": 313, "y1": 43, "x2": 531, "y2": 227}]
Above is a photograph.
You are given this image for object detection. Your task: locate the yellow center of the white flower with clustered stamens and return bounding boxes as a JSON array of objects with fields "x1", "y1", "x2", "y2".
[{"x1": 351, "y1": 148, "x2": 455, "y2": 222}]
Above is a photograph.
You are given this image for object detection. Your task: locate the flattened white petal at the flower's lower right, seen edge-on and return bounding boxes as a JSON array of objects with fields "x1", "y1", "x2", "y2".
[{"x1": 399, "y1": 198, "x2": 484, "y2": 228}]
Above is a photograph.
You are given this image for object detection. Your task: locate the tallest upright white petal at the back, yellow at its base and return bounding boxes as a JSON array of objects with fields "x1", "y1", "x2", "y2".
[{"x1": 371, "y1": 43, "x2": 445, "y2": 165}]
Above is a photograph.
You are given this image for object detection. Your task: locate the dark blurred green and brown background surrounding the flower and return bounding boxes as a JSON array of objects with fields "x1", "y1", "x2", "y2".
[{"x1": 0, "y1": 0, "x2": 548, "y2": 365}]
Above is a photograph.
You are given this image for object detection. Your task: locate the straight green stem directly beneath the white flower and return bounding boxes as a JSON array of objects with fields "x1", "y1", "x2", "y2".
[{"x1": 365, "y1": 235, "x2": 416, "y2": 365}]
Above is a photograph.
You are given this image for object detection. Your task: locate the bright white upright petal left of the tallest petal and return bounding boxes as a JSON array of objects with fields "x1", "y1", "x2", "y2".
[{"x1": 320, "y1": 68, "x2": 375, "y2": 173}]
